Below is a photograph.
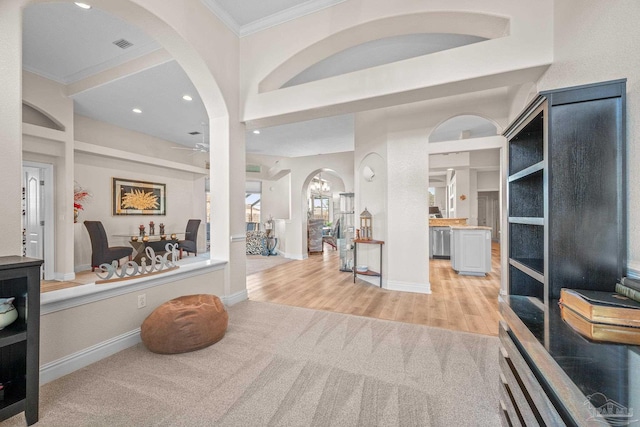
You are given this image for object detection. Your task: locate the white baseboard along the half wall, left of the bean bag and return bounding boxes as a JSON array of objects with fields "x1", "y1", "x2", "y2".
[{"x1": 40, "y1": 328, "x2": 141, "y2": 385}]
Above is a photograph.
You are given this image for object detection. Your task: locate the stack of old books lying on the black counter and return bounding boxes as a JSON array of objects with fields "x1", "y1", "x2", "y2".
[{"x1": 560, "y1": 277, "x2": 640, "y2": 345}]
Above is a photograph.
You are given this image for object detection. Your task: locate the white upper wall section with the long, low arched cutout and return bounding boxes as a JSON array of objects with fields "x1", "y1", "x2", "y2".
[{"x1": 240, "y1": 0, "x2": 553, "y2": 126}]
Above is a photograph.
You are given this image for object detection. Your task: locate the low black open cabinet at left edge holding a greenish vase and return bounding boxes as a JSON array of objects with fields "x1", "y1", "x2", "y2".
[{"x1": 0, "y1": 256, "x2": 42, "y2": 425}]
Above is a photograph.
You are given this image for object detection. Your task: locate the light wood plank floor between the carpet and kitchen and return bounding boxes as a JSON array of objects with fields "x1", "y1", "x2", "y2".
[{"x1": 247, "y1": 243, "x2": 500, "y2": 335}]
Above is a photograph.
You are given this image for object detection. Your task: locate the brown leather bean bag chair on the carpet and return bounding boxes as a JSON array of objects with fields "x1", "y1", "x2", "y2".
[{"x1": 140, "y1": 295, "x2": 229, "y2": 354}]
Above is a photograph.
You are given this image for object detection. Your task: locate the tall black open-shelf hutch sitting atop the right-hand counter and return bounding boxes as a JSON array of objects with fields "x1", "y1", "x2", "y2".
[{"x1": 505, "y1": 80, "x2": 627, "y2": 306}]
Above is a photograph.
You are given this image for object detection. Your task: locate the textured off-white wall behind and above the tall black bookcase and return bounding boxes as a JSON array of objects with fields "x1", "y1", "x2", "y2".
[{"x1": 538, "y1": 0, "x2": 640, "y2": 272}]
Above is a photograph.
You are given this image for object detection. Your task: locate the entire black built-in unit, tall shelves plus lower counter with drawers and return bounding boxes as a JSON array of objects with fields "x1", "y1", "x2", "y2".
[{"x1": 499, "y1": 80, "x2": 640, "y2": 425}]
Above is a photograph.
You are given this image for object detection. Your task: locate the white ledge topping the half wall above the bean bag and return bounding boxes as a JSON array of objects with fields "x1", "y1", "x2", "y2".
[{"x1": 40, "y1": 260, "x2": 227, "y2": 315}]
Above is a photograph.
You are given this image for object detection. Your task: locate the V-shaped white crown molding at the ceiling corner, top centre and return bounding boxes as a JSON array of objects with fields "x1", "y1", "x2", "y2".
[{"x1": 202, "y1": 0, "x2": 346, "y2": 37}]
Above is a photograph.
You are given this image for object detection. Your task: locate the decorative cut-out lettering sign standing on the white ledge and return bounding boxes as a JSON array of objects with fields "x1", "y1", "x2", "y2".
[{"x1": 96, "y1": 243, "x2": 179, "y2": 285}]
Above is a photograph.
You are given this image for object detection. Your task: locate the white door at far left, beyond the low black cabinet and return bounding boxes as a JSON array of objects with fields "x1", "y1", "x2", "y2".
[{"x1": 22, "y1": 166, "x2": 44, "y2": 259}]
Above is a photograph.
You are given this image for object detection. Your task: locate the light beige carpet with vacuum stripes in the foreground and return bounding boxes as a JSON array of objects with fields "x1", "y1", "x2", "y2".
[{"x1": 3, "y1": 301, "x2": 500, "y2": 426}]
